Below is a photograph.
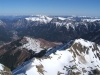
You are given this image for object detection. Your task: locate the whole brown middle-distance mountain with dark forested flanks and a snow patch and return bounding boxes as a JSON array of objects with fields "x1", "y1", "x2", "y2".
[{"x1": 0, "y1": 37, "x2": 57, "y2": 70}]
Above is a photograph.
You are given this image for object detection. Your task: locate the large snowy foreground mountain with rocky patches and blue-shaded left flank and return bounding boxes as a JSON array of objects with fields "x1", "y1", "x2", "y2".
[{"x1": 13, "y1": 39, "x2": 100, "y2": 75}]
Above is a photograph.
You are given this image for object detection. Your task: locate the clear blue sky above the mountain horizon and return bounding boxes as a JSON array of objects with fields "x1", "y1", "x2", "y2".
[{"x1": 0, "y1": 0, "x2": 100, "y2": 16}]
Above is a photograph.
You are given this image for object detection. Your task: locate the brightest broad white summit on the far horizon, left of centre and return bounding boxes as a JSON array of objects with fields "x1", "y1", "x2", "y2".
[{"x1": 25, "y1": 15, "x2": 52, "y2": 23}]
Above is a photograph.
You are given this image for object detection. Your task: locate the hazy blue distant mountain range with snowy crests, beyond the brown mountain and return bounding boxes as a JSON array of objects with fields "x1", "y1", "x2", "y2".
[{"x1": 0, "y1": 15, "x2": 100, "y2": 43}]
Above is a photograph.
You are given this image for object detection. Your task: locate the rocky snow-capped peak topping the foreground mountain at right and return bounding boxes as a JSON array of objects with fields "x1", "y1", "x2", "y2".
[{"x1": 70, "y1": 39, "x2": 100, "y2": 56}]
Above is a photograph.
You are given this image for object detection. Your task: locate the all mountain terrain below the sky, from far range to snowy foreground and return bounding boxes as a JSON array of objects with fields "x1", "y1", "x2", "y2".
[{"x1": 0, "y1": 15, "x2": 100, "y2": 75}]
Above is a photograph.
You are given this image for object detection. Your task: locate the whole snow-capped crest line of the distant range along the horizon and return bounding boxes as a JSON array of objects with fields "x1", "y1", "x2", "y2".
[{"x1": 25, "y1": 15, "x2": 100, "y2": 30}]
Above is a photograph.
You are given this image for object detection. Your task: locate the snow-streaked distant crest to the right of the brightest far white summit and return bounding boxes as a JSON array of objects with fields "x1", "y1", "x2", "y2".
[{"x1": 51, "y1": 16, "x2": 100, "y2": 30}]
